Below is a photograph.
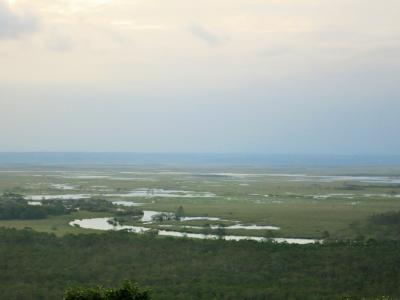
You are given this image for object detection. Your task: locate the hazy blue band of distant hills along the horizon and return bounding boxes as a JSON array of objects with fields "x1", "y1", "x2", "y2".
[{"x1": 0, "y1": 152, "x2": 400, "y2": 167}]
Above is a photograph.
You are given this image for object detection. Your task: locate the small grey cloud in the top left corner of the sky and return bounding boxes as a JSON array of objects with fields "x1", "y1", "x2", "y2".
[{"x1": 0, "y1": 0, "x2": 38, "y2": 39}]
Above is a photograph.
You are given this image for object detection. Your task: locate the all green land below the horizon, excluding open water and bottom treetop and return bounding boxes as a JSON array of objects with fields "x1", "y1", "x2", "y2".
[{"x1": 0, "y1": 167, "x2": 400, "y2": 300}]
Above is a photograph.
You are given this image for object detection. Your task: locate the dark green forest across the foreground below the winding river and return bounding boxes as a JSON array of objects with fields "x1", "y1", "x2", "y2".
[{"x1": 0, "y1": 229, "x2": 400, "y2": 300}]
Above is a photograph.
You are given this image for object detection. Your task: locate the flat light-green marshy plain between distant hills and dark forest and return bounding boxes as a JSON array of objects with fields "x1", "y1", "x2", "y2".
[{"x1": 0, "y1": 167, "x2": 400, "y2": 238}]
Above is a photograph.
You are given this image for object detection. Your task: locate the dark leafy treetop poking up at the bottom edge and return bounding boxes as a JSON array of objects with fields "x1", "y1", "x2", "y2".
[{"x1": 64, "y1": 281, "x2": 151, "y2": 300}]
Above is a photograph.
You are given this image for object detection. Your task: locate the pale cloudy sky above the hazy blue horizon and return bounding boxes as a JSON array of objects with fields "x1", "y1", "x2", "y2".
[{"x1": 0, "y1": 0, "x2": 400, "y2": 154}]
